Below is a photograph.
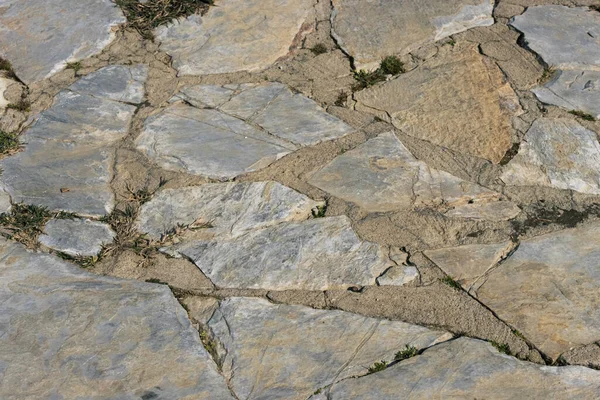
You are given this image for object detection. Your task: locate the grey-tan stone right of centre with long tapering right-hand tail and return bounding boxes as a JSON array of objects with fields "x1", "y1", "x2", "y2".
[{"x1": 309, "y1": 132, "x2": 519, "y2": 219}]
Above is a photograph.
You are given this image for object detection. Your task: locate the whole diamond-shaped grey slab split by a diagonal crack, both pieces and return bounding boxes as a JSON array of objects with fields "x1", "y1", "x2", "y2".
[{"x1": 136, "y1": 83, "x2": 352, "y2": 180}]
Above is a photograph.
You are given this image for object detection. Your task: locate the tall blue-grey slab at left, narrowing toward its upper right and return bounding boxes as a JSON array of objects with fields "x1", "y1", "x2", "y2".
[{"x1": 0, "y1": 67, "x2": 145, "y2": 216}]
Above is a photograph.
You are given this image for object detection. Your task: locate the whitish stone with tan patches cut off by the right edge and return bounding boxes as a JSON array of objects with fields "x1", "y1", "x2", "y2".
[{"x1": 501, "y1": 118, "x2": 600, "y2": 194}]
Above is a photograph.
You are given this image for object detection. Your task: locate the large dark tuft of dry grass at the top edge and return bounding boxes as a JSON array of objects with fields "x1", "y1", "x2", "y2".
[{"x1": 115, "y1": 0, "x2": 213, "y2": 40}]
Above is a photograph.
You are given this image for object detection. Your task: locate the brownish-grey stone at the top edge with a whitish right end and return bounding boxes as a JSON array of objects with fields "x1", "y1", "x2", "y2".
[{"x1": 331, "y1": 0, "x2": 494, "y2": 69}]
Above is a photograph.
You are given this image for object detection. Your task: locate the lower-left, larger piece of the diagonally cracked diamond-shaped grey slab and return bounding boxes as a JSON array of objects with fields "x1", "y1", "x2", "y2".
[{"x1": 136, "y1": 103, "x2": 291, "y2": 180}]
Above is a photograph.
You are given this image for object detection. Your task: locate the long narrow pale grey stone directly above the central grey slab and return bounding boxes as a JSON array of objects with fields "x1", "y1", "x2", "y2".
[{"x1": 136, "y1": 182, "x2": 318, "y2": 239}]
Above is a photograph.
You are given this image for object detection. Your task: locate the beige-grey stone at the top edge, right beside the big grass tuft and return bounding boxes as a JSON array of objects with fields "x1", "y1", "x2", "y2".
[{"x1": 155, "y1": 0, "x2": 315, "y2": 75}]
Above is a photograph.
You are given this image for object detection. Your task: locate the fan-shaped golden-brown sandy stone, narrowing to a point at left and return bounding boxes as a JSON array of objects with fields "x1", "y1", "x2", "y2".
[{"x1": 355, "y1": 45, "x2": 522, "y2": 163}]
